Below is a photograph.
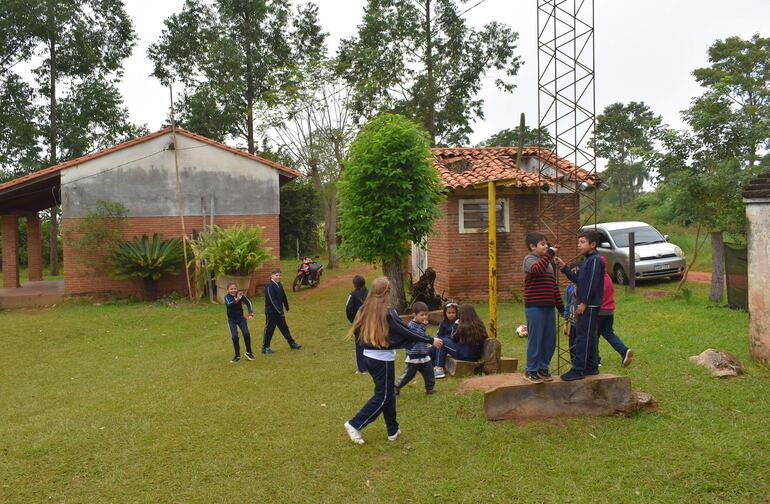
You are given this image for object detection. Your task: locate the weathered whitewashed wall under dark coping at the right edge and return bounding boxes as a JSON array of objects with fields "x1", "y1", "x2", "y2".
[{"x1": 745, "y1": 199, "x2": 770, "y2": 363}]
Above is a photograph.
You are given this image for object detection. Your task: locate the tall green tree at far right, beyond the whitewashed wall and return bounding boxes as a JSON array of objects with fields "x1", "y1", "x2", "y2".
[{"x1": 661, "y1": 35, "x2": 770, "y2": 301}]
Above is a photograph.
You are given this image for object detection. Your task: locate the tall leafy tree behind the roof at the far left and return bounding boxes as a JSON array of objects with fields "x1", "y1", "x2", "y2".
[{"x1": 0, "y1": 0, "x2": 143, "y2": 275}]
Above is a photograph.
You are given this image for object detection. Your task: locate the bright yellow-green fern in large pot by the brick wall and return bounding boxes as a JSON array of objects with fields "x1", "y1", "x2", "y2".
[{"x1": 192, "y1": 225, "x2": 273, "y2": 276}]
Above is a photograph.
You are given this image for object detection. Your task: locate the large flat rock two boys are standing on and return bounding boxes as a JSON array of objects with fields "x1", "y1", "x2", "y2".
[{"x1": 478, "y1": 374, "x2": 639, "y2": 420}]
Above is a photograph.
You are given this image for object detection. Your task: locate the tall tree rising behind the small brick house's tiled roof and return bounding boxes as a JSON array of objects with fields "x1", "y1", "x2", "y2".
[{"x1": 338, "y1": 0, "x2": 521, "y2": 145}]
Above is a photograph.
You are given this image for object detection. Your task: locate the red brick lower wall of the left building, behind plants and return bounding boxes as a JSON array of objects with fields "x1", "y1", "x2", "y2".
[{"x1": 62, "y1": 214, "x2": 281, "y2": 296}]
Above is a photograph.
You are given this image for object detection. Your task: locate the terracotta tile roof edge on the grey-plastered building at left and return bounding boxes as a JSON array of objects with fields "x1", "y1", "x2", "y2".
[{"x1": 0, "y1": 126, "x2": 302, "y2": 191}]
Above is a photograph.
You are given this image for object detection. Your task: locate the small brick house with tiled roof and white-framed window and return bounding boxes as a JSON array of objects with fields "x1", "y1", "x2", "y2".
[{"x1": 411, "y1": 147, "x2": 598, "y2": 299}]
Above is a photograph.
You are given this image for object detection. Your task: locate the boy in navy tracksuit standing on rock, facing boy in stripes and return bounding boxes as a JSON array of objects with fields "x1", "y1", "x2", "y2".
[{"x1": 557, "y1": 231, "x2": 604, "y2": 381}]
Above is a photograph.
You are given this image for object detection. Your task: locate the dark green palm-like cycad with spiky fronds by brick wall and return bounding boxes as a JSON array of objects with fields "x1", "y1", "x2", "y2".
[{"x1": 112, "y1": 233, "x2": 184, "y2": 299}]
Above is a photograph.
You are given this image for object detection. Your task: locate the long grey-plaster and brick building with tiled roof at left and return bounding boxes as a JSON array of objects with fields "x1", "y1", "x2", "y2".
[{"x1": 0, "y1": 128, "x2": 300, "y2": 294}]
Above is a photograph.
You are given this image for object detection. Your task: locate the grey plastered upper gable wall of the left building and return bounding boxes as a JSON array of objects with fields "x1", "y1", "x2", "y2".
[{"x1": 61, "y1": 134, "x2": 280, "y2": 219}]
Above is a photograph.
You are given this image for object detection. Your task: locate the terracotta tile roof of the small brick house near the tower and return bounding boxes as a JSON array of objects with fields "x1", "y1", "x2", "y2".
[{"x1": 432, "y1": 147, "x2": 600, "y2": 189}]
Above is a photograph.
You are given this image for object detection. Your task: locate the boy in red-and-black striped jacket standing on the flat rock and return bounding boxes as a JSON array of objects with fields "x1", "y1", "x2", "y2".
[{"x1": 522, "y1": 232, "x2": 564, "y2": 383}]
